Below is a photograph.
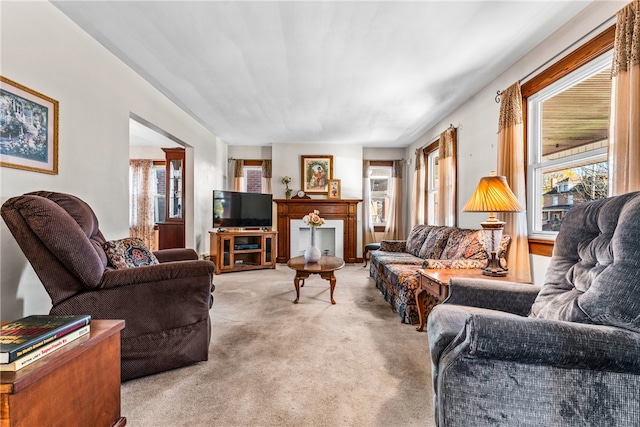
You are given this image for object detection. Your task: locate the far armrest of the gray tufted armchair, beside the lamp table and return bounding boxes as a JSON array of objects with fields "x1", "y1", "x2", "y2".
[{"x1": 445, "y1": 277, "x2": 540, "y2": 316}]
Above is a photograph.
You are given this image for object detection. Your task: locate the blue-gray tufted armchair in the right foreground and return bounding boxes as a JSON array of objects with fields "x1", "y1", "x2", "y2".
[{"x1": 425, "y1": 192, "x2": 640, "y2": 427}]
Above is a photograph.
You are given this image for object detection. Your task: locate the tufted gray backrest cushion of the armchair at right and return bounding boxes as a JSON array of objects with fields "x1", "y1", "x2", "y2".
[{"x1": 530, "y1": 192, "x2": 640, "y2": 332}]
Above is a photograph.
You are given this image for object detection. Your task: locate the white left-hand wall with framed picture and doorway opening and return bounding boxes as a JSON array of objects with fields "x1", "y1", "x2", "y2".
[{"x1": 0, "y1": 1, "x2": 226, "y2": 319}]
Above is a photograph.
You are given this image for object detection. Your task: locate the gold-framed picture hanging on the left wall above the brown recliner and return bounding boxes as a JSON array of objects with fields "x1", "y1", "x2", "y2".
[{"x1": 0, "y1": 76, "x2": 58, "y2": 174}]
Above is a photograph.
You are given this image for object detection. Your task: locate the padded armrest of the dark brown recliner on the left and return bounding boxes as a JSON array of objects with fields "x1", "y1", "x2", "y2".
[{"x1": 98, "y1": 260, "x2": 216, "y2": 289}]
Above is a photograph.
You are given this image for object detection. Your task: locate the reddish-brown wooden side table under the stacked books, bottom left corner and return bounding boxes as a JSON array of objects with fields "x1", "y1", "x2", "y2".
[{"x1": 0, "y1": 320, "x2": 127, "y2": 427}]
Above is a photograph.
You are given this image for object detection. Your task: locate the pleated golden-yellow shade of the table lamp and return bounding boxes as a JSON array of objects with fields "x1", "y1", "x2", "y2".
[{"x1": 462, "y1": 175, "x2": 524, "y2": 212}]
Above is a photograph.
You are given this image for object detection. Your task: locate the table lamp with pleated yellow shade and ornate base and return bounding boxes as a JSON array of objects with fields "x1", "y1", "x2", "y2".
[{"x1": 462, "y1": 172, "x2": 524, "y2": 277}]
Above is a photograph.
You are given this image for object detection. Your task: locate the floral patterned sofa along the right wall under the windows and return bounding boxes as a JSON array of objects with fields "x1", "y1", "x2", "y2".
[{"x1": 369, "y1": 225, "x2": 511, "y2": 324}]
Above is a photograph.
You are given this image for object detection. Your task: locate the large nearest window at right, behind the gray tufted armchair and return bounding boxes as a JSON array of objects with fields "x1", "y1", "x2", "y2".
[{"x1": 522, "y1": 28, "x2": 613, "y2": 241}]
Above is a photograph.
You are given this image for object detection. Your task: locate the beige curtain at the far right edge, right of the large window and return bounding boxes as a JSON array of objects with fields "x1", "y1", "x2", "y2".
[{"x1": 609, "y1": 0, "x2": 640, "y2": 196}]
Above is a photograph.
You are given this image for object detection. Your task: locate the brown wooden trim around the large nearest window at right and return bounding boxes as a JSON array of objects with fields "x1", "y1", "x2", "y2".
[{"x1": 520, "y1": 25, "x2": 616, "y2": 257}]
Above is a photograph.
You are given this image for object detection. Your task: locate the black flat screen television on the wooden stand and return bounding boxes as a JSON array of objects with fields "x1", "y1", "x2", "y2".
[{"x1": 213, "y1": 190, "x2": 273, "y2": 228}]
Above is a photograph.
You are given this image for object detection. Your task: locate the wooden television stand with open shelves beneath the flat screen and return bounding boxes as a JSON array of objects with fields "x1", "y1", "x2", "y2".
[{"x1": 209, "y1": 230, "x2": 278, "y2": 274}]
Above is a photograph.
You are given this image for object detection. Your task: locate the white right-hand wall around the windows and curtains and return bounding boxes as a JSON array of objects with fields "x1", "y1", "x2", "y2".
[{"x1": 405, "y1": 1, "x2": 628, "y2": 283}]
